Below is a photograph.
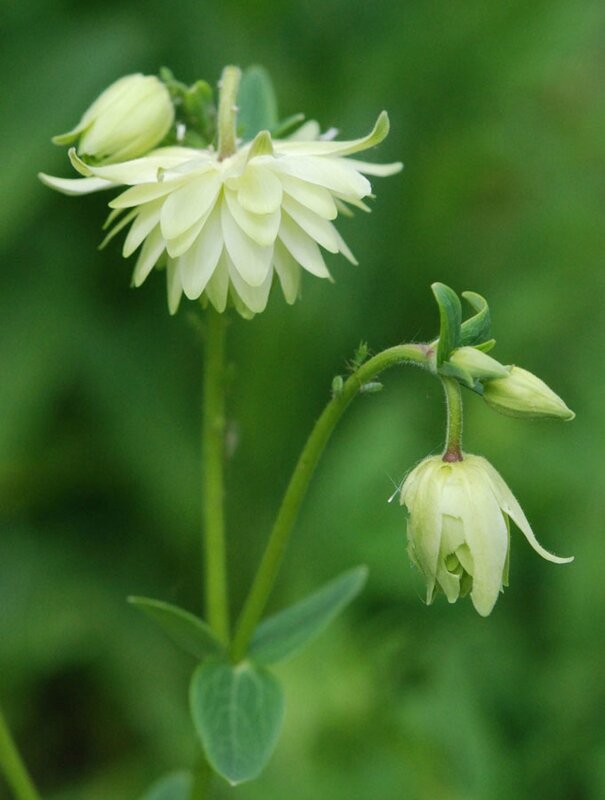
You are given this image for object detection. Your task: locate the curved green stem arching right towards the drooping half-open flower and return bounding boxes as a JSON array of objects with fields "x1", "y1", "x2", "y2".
[{"x1": 232, "y1": 344, "x2": 431, "y2": 663}]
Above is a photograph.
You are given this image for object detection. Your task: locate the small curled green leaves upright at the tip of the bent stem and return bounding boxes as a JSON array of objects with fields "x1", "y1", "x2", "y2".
[{"x1": 431, "y1": 283, "x2": 495, "y2": 368}]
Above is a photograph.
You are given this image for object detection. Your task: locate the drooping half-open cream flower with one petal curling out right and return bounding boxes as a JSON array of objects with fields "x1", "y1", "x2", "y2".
[{"x1": 401, "y1": 454, "x2": 573, "y2": 617}]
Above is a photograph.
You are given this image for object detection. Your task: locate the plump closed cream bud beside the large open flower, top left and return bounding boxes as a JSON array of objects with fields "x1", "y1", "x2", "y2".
[{"x1": 53, "y1": 73, "x2": 174, "y2": 163}]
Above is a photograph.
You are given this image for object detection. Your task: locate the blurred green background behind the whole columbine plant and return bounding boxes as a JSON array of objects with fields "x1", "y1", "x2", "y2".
[{"x1": 0, "y1": 0, "x2": 605, "y2": 800}]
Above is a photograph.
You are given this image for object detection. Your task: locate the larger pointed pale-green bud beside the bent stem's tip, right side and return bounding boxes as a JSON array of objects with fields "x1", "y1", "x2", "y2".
[{"x1": 483, "y1": 367, "x2": 575, "y2": 420}]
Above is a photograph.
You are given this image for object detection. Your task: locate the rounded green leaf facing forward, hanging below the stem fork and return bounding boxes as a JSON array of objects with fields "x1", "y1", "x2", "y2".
[{"x1": 191, "y1": 659, "x2": 284, "y2": 785}]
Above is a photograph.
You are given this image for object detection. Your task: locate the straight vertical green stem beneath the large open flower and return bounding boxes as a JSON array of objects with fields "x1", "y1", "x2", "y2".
[{"x1": 202, "y1": 308, "x2": 229, "y2": 643}]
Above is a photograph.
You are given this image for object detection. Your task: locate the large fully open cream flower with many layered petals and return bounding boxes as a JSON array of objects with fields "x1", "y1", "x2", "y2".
[{"x1": 40, "y1": 112, "x2": 402, "y2": 317}]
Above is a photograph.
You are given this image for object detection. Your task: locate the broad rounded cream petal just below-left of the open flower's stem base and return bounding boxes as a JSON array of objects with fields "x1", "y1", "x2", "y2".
[{"x1": 160, "y1": 171, "x2": 222, "y2": 240}]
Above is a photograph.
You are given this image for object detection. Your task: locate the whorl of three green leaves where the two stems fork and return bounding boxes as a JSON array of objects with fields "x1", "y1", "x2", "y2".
[{"x1": 130, "y1": 567, "x2": 367, "y2": 784}]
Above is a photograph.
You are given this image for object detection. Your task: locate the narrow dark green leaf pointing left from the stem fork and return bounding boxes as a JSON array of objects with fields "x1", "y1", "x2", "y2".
[{"x1": 128, "y1": 597, "x2": 224, "y2": 659}]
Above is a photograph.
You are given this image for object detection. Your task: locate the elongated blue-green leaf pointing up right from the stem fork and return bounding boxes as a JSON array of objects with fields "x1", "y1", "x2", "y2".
[{"x1": 250, "y1": 566, "x2": 368, "y2": 664}]
